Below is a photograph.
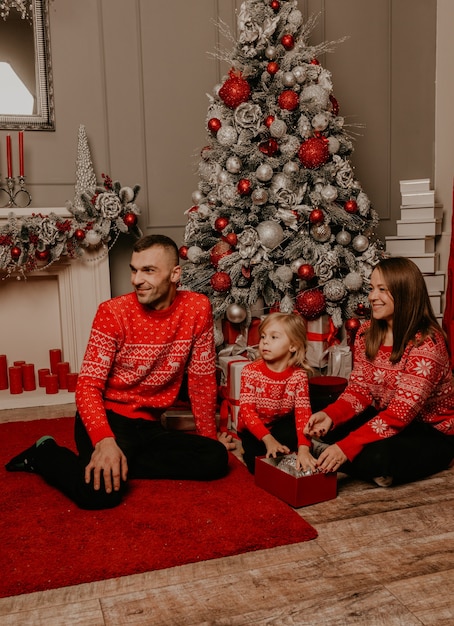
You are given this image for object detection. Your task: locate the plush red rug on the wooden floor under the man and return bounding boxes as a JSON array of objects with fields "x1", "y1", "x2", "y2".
[{"x1": 0, "y1": 418, "x2": 317, "y2": 597}]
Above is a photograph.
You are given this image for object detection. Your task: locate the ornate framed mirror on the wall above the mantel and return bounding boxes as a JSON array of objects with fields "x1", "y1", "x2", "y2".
[{"x1": 0, "y1": 0, "x2": 55, "y2": 130}]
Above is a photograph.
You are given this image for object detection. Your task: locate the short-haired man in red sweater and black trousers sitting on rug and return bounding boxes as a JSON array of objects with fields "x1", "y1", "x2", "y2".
[{"x1": 6, "y1": 235, "x2": 234, "y2": 509}]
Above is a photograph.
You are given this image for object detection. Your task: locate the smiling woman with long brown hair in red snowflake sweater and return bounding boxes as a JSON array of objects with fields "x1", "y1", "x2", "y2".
[{"x1": 305, "y1": 257, "x2": 454, "y2": 487}]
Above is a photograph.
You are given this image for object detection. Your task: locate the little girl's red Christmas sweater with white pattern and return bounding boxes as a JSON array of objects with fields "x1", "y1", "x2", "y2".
[{"x1": 238, "y1": 359, "x2": 311, "y2": 446}]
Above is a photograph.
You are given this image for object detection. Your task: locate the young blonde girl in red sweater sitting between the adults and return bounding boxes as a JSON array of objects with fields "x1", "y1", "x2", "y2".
[{"x1": 238, "y1": 313, "x2": 317, "y2": 474}]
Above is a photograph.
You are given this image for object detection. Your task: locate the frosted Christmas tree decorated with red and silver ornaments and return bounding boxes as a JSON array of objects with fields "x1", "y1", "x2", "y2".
[{"x1": 180, "y1": 0, "x2": 383, "y2": 345}]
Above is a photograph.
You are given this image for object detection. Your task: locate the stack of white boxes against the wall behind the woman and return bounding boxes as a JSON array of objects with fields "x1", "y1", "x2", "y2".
[{"x1": 385, "y1": 178, "x2": 445, "y2": 317}]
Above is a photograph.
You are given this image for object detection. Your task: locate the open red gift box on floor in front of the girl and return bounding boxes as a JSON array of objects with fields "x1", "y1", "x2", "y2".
[{"x1": 255, "y1": 456, "x2": 337, "y2": 508}]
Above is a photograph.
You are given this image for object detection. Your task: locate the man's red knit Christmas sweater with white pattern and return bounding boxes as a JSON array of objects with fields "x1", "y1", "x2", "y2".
[{"x1": 76, "y1": 291, "x2": 217, "y2": 445}]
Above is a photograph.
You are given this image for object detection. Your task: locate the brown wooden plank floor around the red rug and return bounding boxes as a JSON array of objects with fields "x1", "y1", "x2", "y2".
[{"x1": 0, "y1": 406, "x2": 454, "y2": 626}]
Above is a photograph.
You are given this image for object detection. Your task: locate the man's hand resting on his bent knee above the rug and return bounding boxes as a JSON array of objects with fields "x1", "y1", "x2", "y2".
[{"x1": 85, "y1": 437, "x2": 128, "y2": 493}]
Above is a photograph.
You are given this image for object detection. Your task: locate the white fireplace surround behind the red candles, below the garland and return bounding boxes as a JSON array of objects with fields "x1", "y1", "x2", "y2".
[{"x1": 0, "y1": 208, "x2": 110, "y2": 409}]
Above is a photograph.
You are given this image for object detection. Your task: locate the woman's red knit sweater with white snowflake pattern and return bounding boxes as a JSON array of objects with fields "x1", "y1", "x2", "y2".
[{"x1": 324, "y1": 322, "x2": 454, "y2": 461}]
